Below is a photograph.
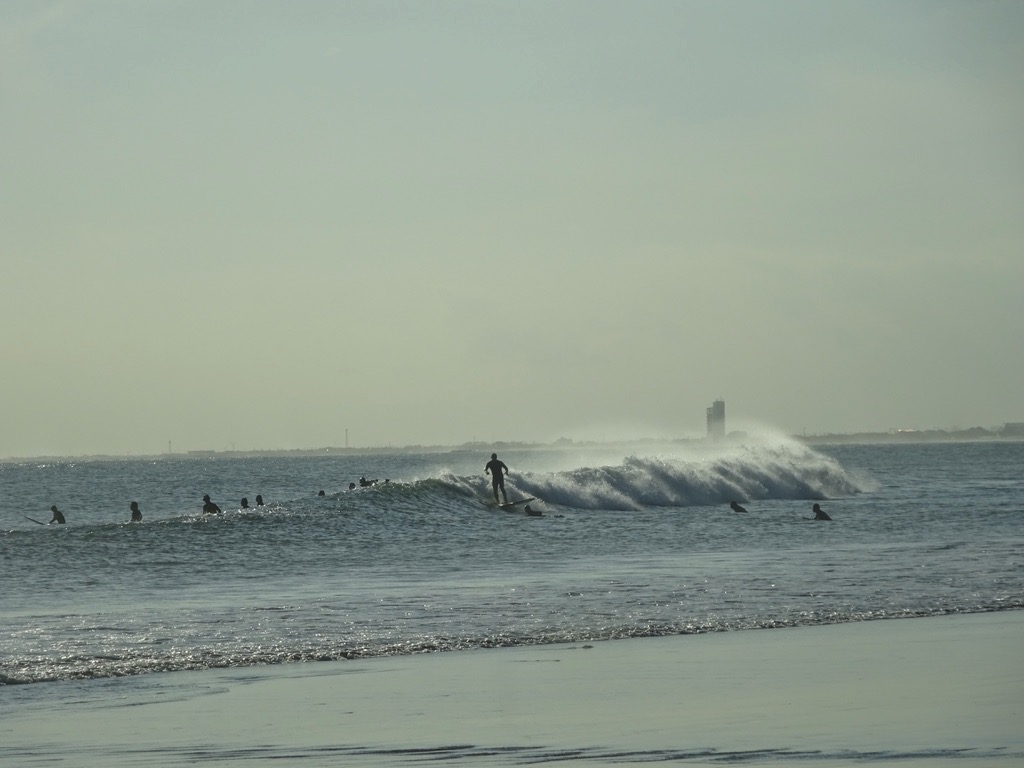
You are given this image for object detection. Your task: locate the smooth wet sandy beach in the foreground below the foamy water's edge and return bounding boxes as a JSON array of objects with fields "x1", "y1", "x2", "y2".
[{"x1": 0, "y1": 610, "x2": 1024, "y2": 767}]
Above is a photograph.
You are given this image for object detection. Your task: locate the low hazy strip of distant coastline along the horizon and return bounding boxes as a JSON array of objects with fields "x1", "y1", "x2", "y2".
[{"x1": 0, "y1": 422, "x2": 1024, "y2": 464}]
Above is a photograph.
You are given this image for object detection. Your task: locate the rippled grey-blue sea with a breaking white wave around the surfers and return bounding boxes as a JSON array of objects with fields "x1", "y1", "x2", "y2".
[{"x1": 0, "y1": 437, "x2": 1024, "y2": 690}]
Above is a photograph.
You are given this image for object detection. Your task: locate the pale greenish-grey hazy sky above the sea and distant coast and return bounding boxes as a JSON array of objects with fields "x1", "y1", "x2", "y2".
[{"x1": 0, "y1": 0, "x2": 1024, "y2": 457}]
